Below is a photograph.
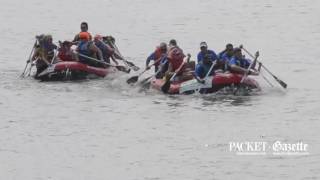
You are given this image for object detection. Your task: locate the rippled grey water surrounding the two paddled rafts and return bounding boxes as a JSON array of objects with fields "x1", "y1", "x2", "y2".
[{"x1": 0, "y1": 0, "x2": 320, "y2": 180}]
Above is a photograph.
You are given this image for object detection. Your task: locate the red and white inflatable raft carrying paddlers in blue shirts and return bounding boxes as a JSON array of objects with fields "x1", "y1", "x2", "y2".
[{"x1": 151, "y1": 73, "x2": 260, "y2": 94}]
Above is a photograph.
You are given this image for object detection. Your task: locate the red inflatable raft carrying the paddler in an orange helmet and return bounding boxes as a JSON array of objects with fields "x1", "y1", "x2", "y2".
[{"x1": 37, "y1": 61, "x2": 117, "y2": 81}]
